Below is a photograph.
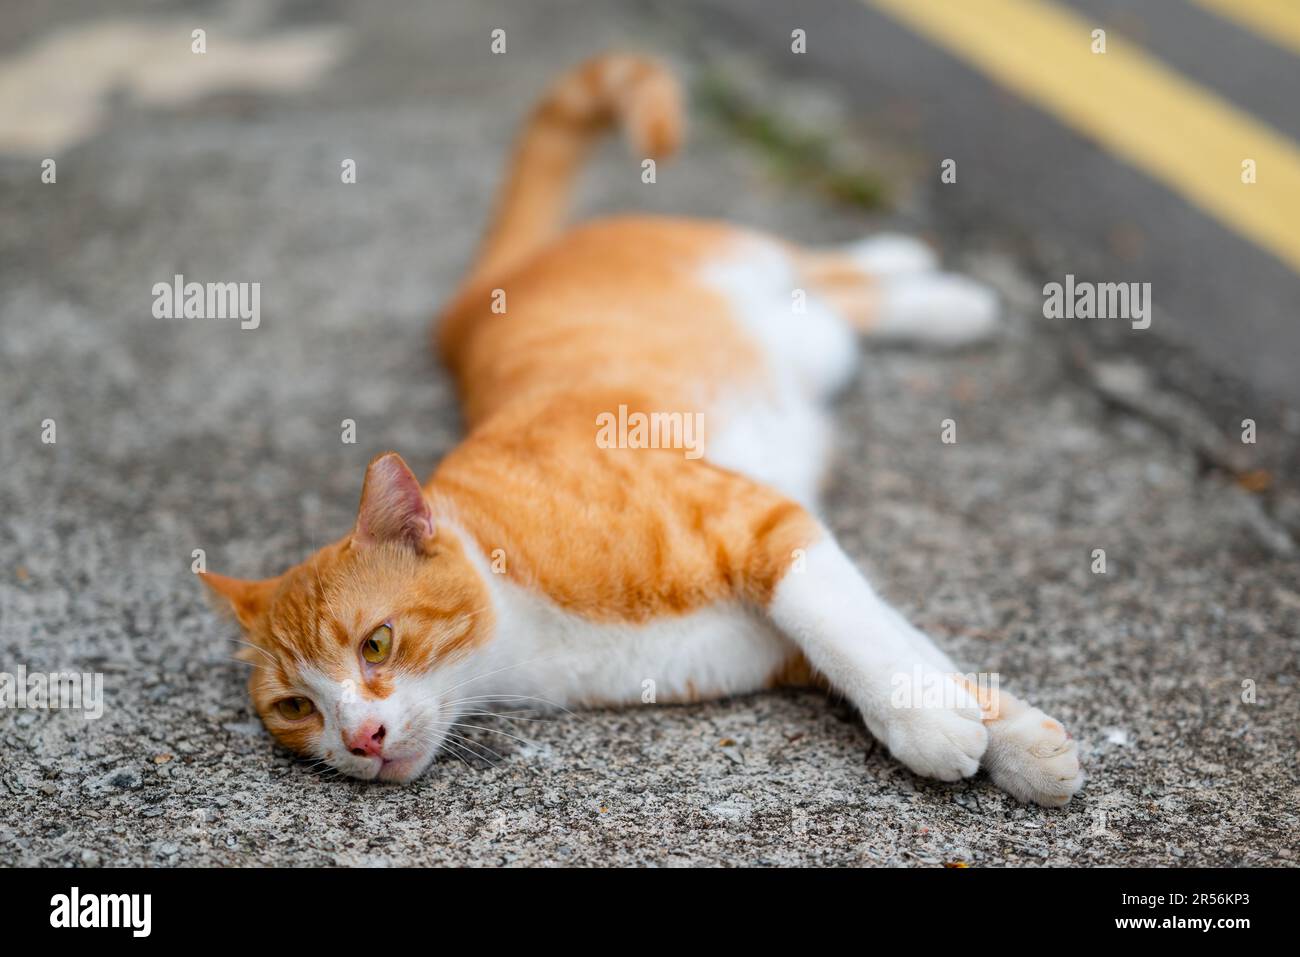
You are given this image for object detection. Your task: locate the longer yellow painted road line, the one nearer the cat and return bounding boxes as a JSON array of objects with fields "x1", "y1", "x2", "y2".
[{"x1": 862, "y1": 0, "x2": 1300, "y2": 272}]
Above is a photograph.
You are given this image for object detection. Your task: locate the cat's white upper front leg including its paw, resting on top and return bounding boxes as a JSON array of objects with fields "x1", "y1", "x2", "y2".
[{"x1": 767, "y1": 533, "x2": 989, "y2": 781}]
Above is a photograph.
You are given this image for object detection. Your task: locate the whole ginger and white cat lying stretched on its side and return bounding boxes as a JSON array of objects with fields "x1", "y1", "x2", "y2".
[{"x1": 204, "y1": 55, "x2": 1083, "y2": 805}]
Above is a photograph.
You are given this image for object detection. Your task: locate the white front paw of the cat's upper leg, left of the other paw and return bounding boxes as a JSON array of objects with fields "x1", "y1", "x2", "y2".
[{"x1": 884, "y1": 677, "x2": 988, "y2": 781}]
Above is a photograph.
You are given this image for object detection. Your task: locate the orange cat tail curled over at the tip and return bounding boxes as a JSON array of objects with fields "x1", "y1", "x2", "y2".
[{"x1": 465, "y1": 53, "x2": 685, "y2": 286}]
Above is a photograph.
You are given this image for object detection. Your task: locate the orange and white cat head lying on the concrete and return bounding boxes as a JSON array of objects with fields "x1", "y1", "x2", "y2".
[{"x1": 203, "y1": 452, "x2": 493, "y2": 781}]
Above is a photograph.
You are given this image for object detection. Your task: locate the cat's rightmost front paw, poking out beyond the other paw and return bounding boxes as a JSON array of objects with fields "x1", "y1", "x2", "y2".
[{"x1": 984, "y1": 707, "x2": 1083, "y2": 807}]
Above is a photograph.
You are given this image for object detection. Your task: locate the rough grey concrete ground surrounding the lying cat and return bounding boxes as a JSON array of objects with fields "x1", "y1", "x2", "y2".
[{"x1": 0, "y1": 0, "x2": 1300, "y2": 866}]
